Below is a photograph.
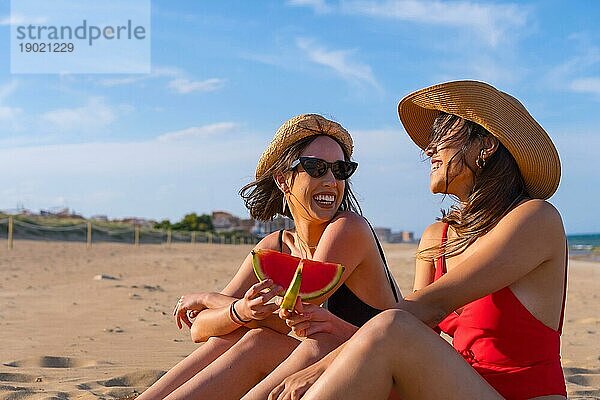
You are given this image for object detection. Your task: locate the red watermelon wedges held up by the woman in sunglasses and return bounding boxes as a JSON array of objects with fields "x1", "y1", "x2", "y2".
[{"x1": 252, "y1": 249, "x2": 344, "y2": 300}]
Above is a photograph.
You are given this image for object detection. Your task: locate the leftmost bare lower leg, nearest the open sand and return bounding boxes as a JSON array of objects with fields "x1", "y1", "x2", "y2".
[{"x1": 137, "y1": 328, "x2": 248, "y2": 400}]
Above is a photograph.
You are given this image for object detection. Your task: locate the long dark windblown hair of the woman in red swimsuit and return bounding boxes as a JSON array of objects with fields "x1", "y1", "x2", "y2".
[{"x1": 417, "y1": 112, "x2": 530, "y2": 260}]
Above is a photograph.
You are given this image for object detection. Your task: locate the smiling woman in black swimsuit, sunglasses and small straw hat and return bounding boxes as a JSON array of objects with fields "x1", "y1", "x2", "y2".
[{"x1": 138, "y1": 114, "x2": 400, "y2": 399}]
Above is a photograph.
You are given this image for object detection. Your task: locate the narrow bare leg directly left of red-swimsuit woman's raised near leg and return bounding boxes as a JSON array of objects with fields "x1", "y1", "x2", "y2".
[{"x1": 242, "y1": 333, "x2": 343, "y2": 400}]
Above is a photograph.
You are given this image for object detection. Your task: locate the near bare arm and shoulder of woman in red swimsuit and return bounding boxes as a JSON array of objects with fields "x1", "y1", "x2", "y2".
[{"x1": 399, "y1": 200, "x2": 565, "y2": 326}]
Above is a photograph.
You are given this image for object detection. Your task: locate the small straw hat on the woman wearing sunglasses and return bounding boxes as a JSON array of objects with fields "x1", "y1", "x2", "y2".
[{"x1": 256, "y1": 114, "x2": 353, "y2": 178}]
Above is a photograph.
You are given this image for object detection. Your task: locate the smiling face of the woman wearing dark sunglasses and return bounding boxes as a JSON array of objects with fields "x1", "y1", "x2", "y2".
[{"x1": 288, "y1": 136, "x2": 346, "y2": 223}]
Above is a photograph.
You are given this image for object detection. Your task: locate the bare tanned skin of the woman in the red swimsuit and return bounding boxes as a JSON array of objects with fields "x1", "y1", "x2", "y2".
[{"x1": 269, "y1": 122, "x2": 566, "y2": 400}]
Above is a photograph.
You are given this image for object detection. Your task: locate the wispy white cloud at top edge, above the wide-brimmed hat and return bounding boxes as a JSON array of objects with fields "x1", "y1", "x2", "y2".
[{"x1": 340, "y1": 0, "x2": 529, "y2": 46}]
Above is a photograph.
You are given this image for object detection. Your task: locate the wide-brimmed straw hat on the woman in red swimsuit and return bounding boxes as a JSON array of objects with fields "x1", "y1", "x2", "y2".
[{"x1": 398, "y1": 80, "x2": 560, "y2": 199}]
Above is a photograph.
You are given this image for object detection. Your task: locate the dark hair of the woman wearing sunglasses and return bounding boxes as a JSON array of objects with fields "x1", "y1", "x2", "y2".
[{"x1": 240, "y1": 135, "x2": 362, "y2": 221}]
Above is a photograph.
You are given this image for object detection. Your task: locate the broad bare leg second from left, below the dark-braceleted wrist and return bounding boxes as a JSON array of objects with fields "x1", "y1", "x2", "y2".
[{"x1": 165, "y1": 328, "x2": 299, "y2": 400}]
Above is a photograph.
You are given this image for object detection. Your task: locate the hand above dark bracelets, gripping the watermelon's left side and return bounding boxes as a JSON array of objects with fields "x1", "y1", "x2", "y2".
[{"x1": 235, "y1": 279, "x2": 283, "y2": 321}]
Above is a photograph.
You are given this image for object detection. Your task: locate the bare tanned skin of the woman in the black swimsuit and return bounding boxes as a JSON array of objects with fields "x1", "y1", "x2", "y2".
[{"x1": 138, "y1": 136, "x2": 395, "y2": 400}]
